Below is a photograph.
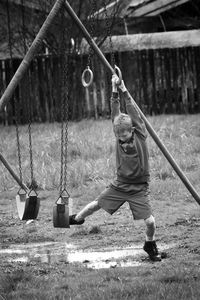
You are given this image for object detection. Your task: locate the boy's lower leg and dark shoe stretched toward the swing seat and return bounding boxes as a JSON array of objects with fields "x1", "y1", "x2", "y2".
[{"x1": 69, "y1": 200, "x2": 101, "y2": 225}]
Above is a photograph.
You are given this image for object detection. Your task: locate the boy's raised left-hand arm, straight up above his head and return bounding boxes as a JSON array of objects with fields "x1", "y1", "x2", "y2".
[{"x1": 110, "y1": 75, "x2": 120, "y2": 122}]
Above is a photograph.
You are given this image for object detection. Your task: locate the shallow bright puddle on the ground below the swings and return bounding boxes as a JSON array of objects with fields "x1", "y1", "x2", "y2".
[{"x1": 0, "y1": 242, "x2": 173, "y2": 269}]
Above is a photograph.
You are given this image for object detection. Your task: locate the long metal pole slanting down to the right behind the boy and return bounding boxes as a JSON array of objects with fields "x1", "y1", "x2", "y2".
[{"x1": 65, "y1": 1, "x2": 200, "y2": 204}]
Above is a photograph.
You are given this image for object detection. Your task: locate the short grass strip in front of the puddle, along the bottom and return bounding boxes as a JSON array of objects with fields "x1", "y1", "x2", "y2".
[{"x1": 0, "y1": 265, "x2": 200, "y2": 300}]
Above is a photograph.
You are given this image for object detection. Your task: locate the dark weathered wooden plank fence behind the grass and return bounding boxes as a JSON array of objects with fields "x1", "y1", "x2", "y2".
[{"x1": 0, "y1": 47, "x2": 200, "y2": 124}]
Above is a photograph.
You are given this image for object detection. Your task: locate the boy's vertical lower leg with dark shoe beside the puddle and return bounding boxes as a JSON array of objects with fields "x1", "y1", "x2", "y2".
[{"x1": 143, "y1": 215, "x2": 161, "y2": 261}]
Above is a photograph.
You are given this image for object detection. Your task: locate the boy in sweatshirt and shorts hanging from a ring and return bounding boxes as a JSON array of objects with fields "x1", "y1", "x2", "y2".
[{"x1": 69, "y1": 75, "x2": 161, "y2": 261}]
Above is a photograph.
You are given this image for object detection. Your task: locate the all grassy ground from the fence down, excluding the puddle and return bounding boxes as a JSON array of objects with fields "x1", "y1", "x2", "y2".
[{"x1": 0, "y1": 115, "x2": 200, "y2": 300}]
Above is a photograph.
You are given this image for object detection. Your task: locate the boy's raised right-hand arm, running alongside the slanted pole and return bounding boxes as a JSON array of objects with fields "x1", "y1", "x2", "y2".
[{"x1": 119, "y1": 81, "x2": 147, "y2": 138}]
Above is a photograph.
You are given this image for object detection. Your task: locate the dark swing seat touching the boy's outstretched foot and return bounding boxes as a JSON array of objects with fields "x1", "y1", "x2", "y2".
[{"x1": 53, "y1": 196, "x2": 70, "y2": 228}]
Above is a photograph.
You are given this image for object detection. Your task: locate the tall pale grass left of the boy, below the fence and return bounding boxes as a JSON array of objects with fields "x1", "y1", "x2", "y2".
[{"x1": 0, "y1": 121, "x2": 114, "y2": 190}]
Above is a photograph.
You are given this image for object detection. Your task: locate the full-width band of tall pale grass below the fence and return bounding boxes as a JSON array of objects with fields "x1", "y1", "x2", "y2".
[{"x1": 0, "y1": 116, "x2": 200, "y2": 195}]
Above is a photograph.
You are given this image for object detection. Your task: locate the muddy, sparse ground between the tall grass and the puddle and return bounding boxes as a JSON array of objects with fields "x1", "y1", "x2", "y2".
[{"x1": 0, "y1": 186, "x2": 200, "y2": 262}]
